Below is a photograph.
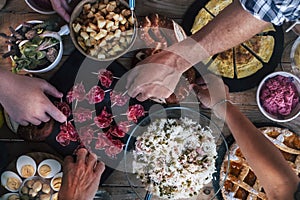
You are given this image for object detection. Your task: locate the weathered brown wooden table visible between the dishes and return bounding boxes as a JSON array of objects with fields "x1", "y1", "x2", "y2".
[{"x1": 0, "y1": 0, "x2": 300, "y2": 200}]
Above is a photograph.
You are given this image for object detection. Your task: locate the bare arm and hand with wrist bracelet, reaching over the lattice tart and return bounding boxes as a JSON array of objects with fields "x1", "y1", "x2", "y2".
[{"x1": 194, "y1": 76, "x2": 299, "y2": 199}]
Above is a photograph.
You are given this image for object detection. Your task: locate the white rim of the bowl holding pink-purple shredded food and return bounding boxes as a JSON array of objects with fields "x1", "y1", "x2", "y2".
[{"x1": 256, "y1": 71, "x2": 300, "y2": 122}]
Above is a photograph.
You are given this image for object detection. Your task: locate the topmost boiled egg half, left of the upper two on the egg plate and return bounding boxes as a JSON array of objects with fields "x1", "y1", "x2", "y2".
[{"x1": 16, "y1": 155, "x2": 36, "y2": 178}]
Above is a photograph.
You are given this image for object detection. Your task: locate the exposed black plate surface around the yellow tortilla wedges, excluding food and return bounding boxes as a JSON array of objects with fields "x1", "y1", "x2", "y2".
[{"x1": 182, "y1": 0, "x2": 283, "y2": 92}]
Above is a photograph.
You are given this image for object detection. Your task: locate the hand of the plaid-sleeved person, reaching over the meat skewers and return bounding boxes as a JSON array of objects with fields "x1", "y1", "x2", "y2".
[{"x1": 126, "y1": 51, "x2": 189, "y2": 101}]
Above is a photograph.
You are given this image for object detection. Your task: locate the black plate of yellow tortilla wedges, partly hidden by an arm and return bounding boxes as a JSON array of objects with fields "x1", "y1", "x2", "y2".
[{"x1": 182, "y1": 0, "x2": 283, "y2": 92}]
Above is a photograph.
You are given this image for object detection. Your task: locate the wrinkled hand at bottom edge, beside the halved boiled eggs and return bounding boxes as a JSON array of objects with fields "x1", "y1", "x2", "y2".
[{"x1": 58, "y1": 148, "x2": 105, "y2": 200}]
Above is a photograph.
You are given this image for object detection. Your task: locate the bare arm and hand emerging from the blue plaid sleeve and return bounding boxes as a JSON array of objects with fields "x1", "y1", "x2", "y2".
[{"x1": 126, "y1": 0, "x2": 268, "y2": 101}]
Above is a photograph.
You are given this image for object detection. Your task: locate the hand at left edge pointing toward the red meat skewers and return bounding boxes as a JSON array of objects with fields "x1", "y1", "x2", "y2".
[{"x1": 0, "y1": 72, "x2": 66, "y2": 126}]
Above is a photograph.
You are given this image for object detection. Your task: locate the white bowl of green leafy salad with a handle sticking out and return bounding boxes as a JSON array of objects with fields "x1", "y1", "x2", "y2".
[{"x1": 4, "y1": 20, "x2": 68, "y2": 73}]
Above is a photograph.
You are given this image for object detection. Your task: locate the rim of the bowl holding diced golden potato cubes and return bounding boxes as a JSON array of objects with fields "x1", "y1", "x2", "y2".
[{"x1": 69, "y1": 0, "x2": 138, "y2": 61}]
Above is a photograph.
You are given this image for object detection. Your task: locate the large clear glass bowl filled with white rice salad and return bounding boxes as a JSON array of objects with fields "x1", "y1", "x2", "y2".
[{"x1": 125, "y1": 107, "x2": 230, "y2": 199}]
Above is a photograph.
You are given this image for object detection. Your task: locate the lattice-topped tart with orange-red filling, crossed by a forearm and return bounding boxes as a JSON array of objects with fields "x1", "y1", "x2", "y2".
[{"x1": 214, "y1": 124, "x2": 300, "y2": 200}]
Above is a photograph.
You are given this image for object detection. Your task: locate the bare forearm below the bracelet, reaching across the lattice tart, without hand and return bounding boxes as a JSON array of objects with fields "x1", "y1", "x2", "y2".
[{"x1": 217, "y1": 103, "x2": 299, "y2": 199}]
